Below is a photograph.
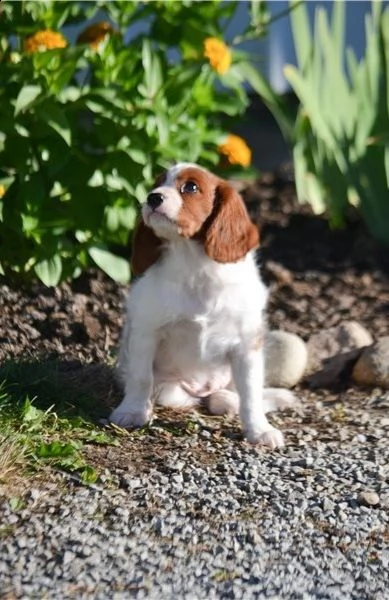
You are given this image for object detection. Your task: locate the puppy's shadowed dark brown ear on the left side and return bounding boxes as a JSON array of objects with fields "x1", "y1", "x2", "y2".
[{"x1": 131, "y1": 218, "x2": 162, "y2": 275}]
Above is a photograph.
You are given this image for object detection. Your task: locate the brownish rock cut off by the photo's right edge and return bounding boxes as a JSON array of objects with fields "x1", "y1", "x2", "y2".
[{"x1": 352, "y1": 335, "x2": 389, "y2": 389}]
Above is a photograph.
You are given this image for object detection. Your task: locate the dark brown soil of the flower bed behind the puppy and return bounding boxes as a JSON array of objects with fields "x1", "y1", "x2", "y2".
[{"x1": 0, "y1": 165, "x2": 389, "y2": 474}]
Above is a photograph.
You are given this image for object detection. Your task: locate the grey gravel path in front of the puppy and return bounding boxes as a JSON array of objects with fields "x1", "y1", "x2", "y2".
[{"x1": 0, "y1": 393, "x2": 389, "y2": 600}]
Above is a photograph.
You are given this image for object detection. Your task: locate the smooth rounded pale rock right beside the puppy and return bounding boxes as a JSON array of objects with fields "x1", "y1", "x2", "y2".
[{"x1": 265, "y1": 331, "x2": 308, "y2": 388}]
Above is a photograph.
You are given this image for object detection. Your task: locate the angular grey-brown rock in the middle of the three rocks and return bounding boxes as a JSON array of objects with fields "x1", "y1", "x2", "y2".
[{"x1": 307, "y1": 321, "x2": 373, "y2": 387}]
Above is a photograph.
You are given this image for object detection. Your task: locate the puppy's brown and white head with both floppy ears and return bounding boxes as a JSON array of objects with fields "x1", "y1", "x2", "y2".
[{"x1": 132, "y1": 163, "x2": 259, "y2": 274}]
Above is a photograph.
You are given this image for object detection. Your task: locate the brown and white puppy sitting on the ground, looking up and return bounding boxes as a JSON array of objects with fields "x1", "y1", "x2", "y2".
[{"x1": 110, "y1": 163, "x2": 294, "y2": 448}]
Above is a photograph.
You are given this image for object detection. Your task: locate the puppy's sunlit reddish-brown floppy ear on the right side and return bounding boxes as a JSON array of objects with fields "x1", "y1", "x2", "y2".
[{"x1": 204, "y1": 181, "x2": 259, "y2": 263}]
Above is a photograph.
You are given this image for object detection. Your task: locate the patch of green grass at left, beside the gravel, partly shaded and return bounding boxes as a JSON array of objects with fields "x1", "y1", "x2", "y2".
[{"x1": 0, "y1": 362, "x2": 119, "y2": 483}]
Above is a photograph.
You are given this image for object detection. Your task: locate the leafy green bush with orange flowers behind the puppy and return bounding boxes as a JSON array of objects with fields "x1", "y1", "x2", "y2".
[{"x1": 0, "y1": 0, "x2": 287, "y2": 285}]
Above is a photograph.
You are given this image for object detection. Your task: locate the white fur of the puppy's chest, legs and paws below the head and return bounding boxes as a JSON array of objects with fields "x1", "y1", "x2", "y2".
[{"x1": 110, "y1": 167, "x2": 294, "y2": 448}]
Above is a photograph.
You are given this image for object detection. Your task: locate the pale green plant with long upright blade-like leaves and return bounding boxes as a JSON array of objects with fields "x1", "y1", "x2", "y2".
[{"x1": 285, "y1": 1, "x2": 389, "y2": 244}]
